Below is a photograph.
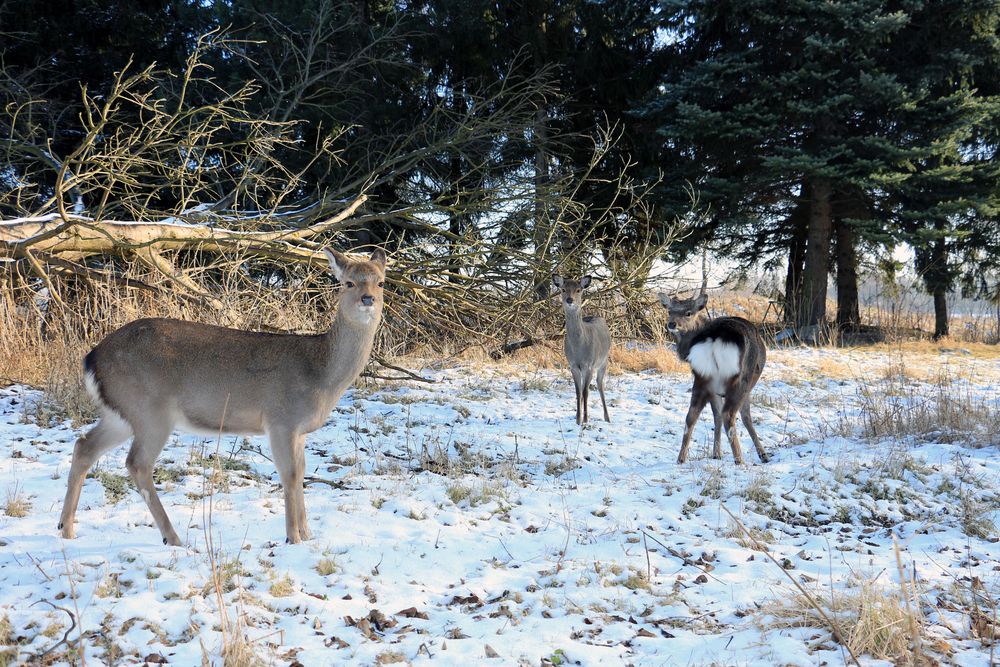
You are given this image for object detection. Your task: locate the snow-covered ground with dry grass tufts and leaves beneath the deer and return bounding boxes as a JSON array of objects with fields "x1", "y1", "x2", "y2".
[{"x1": 0, "y1": 350, "x2": 1000, "y2": 665}]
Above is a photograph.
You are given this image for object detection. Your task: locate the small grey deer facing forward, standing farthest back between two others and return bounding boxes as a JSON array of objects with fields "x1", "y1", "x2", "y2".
[{"x1": 552, "y1": 276, "x2": 611, "y2": 424}]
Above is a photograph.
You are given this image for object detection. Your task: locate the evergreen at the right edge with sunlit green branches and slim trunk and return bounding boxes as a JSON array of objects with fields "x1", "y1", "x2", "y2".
[{"x1": 888, "y1": 0, "x2": 1000, "y2": 338}]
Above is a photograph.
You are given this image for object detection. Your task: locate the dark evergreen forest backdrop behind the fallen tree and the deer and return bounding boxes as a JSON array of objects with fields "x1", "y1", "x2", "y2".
[{"x1": 0, "y1": 0, "x2": 1000, "y2": 336}]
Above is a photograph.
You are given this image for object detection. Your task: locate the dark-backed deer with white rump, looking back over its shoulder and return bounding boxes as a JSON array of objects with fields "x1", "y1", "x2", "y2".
[{"x1": 659, "y1": 286, "x2": 767, "y2": 464}]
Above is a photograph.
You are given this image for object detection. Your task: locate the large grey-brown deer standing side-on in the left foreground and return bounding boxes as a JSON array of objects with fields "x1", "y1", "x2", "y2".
[{"x1": 59, "y1": 250, "x2": 385, "y2": 545}]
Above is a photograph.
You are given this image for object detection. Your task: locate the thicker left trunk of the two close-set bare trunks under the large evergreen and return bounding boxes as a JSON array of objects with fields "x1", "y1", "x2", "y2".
[{"x1": 796, "y1": 179, "x2": 833, "y2": 329}]
